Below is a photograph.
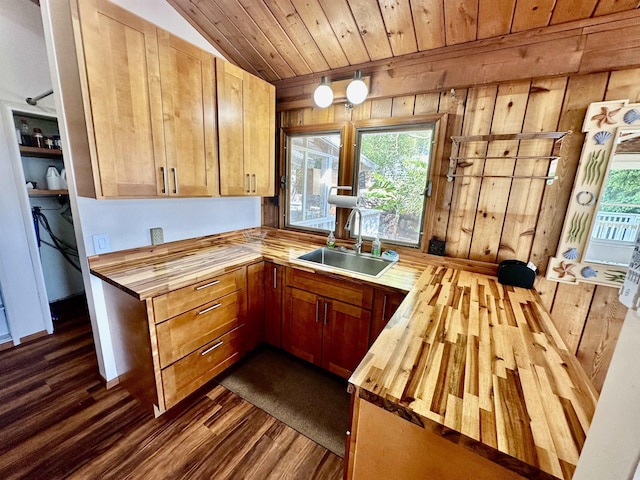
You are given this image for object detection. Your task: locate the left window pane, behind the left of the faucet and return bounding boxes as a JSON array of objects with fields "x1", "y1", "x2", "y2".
[{"x1": 286, "y1": 132, "x2": 341, "y2": 232}]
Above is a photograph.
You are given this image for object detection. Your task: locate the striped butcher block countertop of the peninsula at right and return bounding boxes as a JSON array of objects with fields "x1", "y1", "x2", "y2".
[{"x1": 349, "y1": 266, "x2": 597, "y2": 479}]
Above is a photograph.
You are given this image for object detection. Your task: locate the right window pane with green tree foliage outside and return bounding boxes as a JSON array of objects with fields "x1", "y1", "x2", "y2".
[{"x1": 352, "y1": 124, "x2": 435, "y2": 246}]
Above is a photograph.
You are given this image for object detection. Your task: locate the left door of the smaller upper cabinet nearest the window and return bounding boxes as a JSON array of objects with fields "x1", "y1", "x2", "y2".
[{"x1": 216, "y1": 60, "x2": 245, "y2": 196}]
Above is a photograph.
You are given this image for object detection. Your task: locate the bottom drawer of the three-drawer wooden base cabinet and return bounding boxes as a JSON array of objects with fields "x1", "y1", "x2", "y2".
[{"x1": 162, "y1": 325, "x2": 244, "y2": 408}]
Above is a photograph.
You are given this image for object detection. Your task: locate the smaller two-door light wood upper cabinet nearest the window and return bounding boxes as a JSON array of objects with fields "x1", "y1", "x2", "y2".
[{"x1": 216, "y1": 59, "x2": 275, "y2": 196}]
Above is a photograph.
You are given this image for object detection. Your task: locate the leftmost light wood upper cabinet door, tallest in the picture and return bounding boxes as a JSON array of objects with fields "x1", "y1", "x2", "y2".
[{"x1": 78, "y1": 0, "x2": 166, "y2": 197}]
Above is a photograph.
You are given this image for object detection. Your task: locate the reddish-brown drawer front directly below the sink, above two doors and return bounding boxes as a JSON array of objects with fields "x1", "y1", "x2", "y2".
[{"x1": 287, "y1": 268, "x2": 373, "y2": 310}]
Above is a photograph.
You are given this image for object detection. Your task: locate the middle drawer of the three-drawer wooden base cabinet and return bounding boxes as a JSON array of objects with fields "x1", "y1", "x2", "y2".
[{"x1": 156, "y1": 291, "x2": 243, "y2": 368}]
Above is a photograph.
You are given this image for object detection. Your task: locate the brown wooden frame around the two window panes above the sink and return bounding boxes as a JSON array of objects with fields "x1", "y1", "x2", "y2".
[{"x1": 278, "y1": 113, "x2": 453, "y2": 252}]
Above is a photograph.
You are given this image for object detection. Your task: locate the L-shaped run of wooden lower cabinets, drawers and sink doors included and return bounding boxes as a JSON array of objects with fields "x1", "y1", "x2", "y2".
[{"x1": 105, "y1": 262, "x2": 403, "y2": 415}]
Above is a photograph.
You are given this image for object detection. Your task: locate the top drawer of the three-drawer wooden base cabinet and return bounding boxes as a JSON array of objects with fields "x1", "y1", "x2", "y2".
[{"x1": 153, "y1": 268, "x2": 245, "y2": 323}]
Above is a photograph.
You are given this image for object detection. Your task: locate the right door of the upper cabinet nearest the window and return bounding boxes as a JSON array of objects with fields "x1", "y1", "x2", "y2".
[{"x1": 244, "y1": 73, "x2": 276, "y2": 197}]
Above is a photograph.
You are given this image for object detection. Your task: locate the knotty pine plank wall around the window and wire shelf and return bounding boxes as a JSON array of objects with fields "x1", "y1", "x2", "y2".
[{"x1": 263, "y1": 69, "x2": 640, "y2": 389}]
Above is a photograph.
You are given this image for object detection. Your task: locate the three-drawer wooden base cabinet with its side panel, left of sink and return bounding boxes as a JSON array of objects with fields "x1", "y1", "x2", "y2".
[{"x1": 105, "y1": 263, "x2": 248, "y2": 416}]
